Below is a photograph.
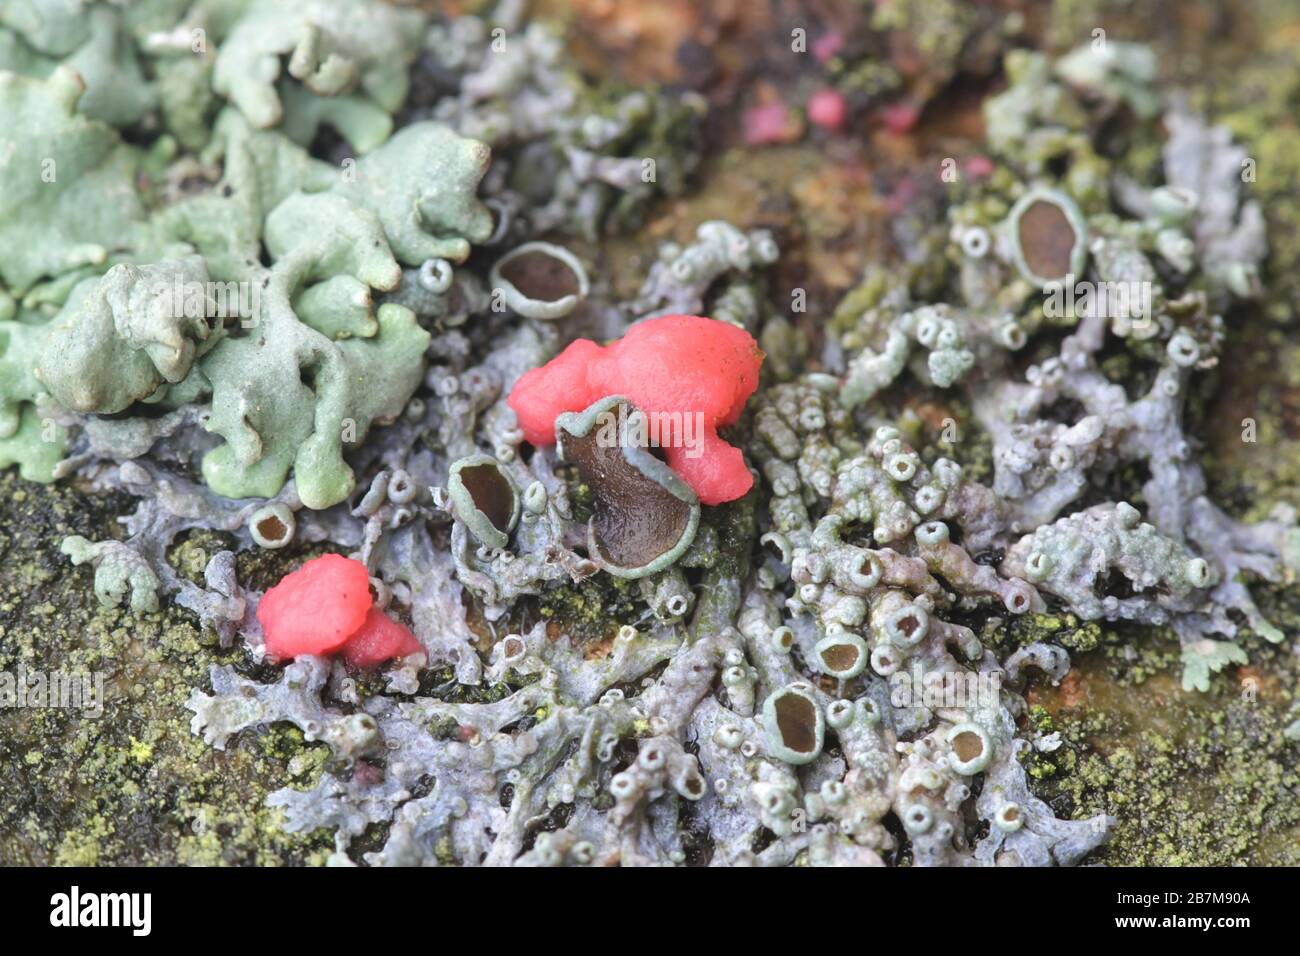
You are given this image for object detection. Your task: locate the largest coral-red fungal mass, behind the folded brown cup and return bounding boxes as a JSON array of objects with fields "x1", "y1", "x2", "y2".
[{"x1": 508, "y1": 315, "x2": 763, "y2": 505}]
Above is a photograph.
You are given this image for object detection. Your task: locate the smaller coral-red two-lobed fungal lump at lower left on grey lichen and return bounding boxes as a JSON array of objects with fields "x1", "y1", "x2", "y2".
[{"x1": 257, "y1": 554, "x2": 423, "y2": 667}]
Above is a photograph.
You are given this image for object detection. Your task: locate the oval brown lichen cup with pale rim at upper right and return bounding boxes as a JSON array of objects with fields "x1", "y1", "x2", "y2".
[{"x1": 1006, "y1": 189, "x2": 1088, "y2": 287}]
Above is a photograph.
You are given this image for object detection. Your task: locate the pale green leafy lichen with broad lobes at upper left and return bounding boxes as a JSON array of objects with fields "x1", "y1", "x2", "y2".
[{"x1": 0, "y1": 38, "x2": 491, "y2": 507}]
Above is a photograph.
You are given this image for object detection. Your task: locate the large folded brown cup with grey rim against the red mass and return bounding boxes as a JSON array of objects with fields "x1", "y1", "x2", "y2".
[{"x1": 555, "y1": 395, "x2": 699, "y2": 578}]
